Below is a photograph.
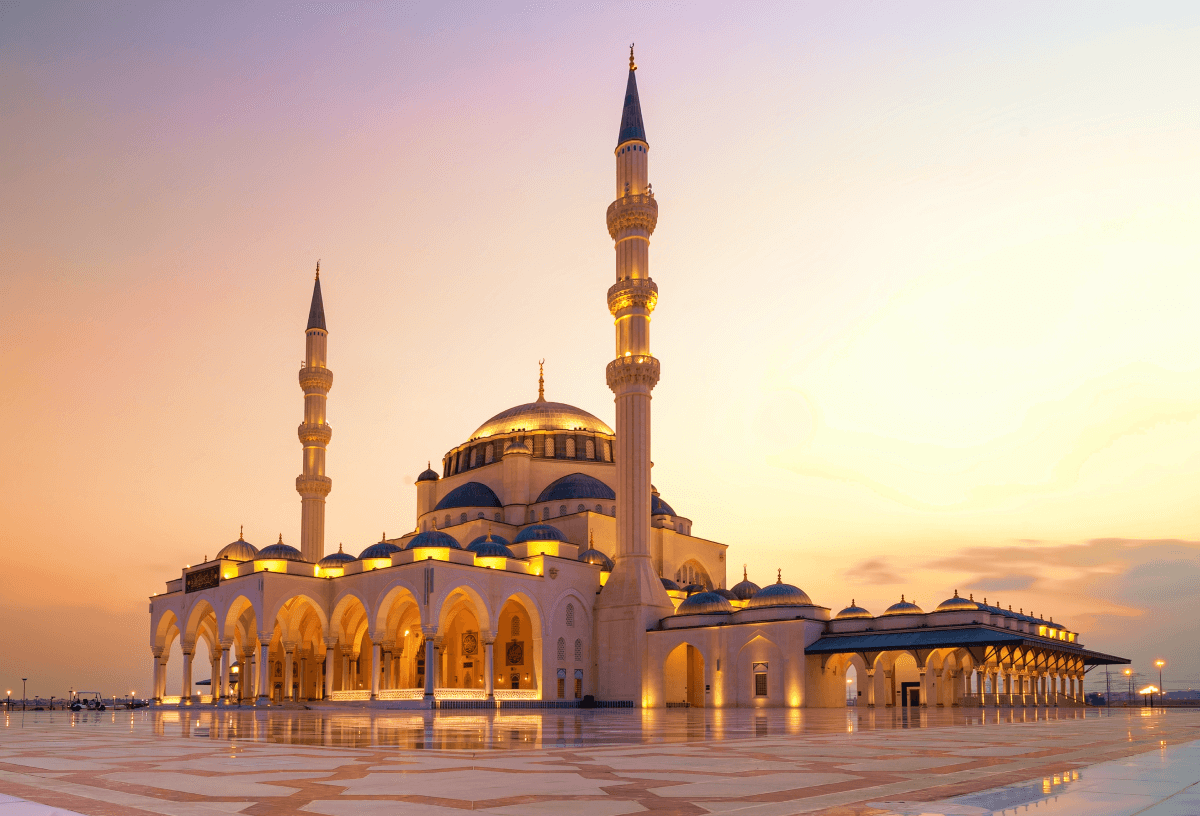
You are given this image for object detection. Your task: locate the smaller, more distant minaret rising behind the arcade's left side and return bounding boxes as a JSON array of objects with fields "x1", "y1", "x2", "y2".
[{"x1": 296, "y1": 260, "x2": 334, "y2": 564}]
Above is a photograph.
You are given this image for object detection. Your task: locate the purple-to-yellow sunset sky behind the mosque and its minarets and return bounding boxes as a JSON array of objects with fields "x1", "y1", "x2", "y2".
[{"x1": 0, "y1": 2, "x2": 1200, "y2": 696}]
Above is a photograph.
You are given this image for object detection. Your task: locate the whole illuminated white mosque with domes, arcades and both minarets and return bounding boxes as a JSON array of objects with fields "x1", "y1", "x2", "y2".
[{"x1": 150, "y1": 49, "x2": 1128, "y2": 708}]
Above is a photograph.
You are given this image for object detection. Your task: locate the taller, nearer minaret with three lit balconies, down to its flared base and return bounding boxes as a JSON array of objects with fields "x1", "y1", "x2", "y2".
[{"x1": 596, "y1": 46, "x2": 673, "y2": 704}]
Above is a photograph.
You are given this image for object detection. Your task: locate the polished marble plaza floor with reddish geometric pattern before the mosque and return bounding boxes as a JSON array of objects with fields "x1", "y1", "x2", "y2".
[{"x1": 0, "y1": 708, "x2": 1200, "y2": 816}]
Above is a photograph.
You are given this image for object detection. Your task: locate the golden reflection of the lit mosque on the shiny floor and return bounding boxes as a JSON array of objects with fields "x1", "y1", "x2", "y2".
[{"x1": 56, "y1": 707, "x2": 1104, "y2": 750}]
